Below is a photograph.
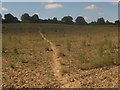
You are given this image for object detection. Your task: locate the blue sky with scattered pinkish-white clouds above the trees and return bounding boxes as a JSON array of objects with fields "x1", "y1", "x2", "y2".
[{"x1": 2, "y1": 0, "x2": 118, "y2": 22}]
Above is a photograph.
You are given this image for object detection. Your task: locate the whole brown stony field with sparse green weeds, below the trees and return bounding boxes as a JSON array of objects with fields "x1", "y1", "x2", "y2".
[{"x1": 2, "y1": 24, "x2": 120, "y2": 88}]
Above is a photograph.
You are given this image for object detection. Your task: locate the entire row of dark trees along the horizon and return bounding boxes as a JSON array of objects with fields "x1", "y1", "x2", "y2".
[{"x1": 0, "y1": 13, "x2": 120, "y2": 25}]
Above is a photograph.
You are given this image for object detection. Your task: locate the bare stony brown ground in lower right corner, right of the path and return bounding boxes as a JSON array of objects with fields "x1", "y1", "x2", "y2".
[{"x1": 65, "y1": 66, "x2": 118, "y2": 88}]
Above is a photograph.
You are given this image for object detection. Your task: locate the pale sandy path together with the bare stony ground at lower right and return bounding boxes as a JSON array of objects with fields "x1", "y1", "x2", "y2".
[{"x1": 40, "y1": 32, "x2": 118, "y2": 88}]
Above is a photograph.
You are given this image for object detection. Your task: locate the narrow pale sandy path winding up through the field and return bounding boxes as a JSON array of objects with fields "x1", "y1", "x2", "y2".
[{"x1": 39, "y1": 31, "x2": 74, "y2": 88}]
